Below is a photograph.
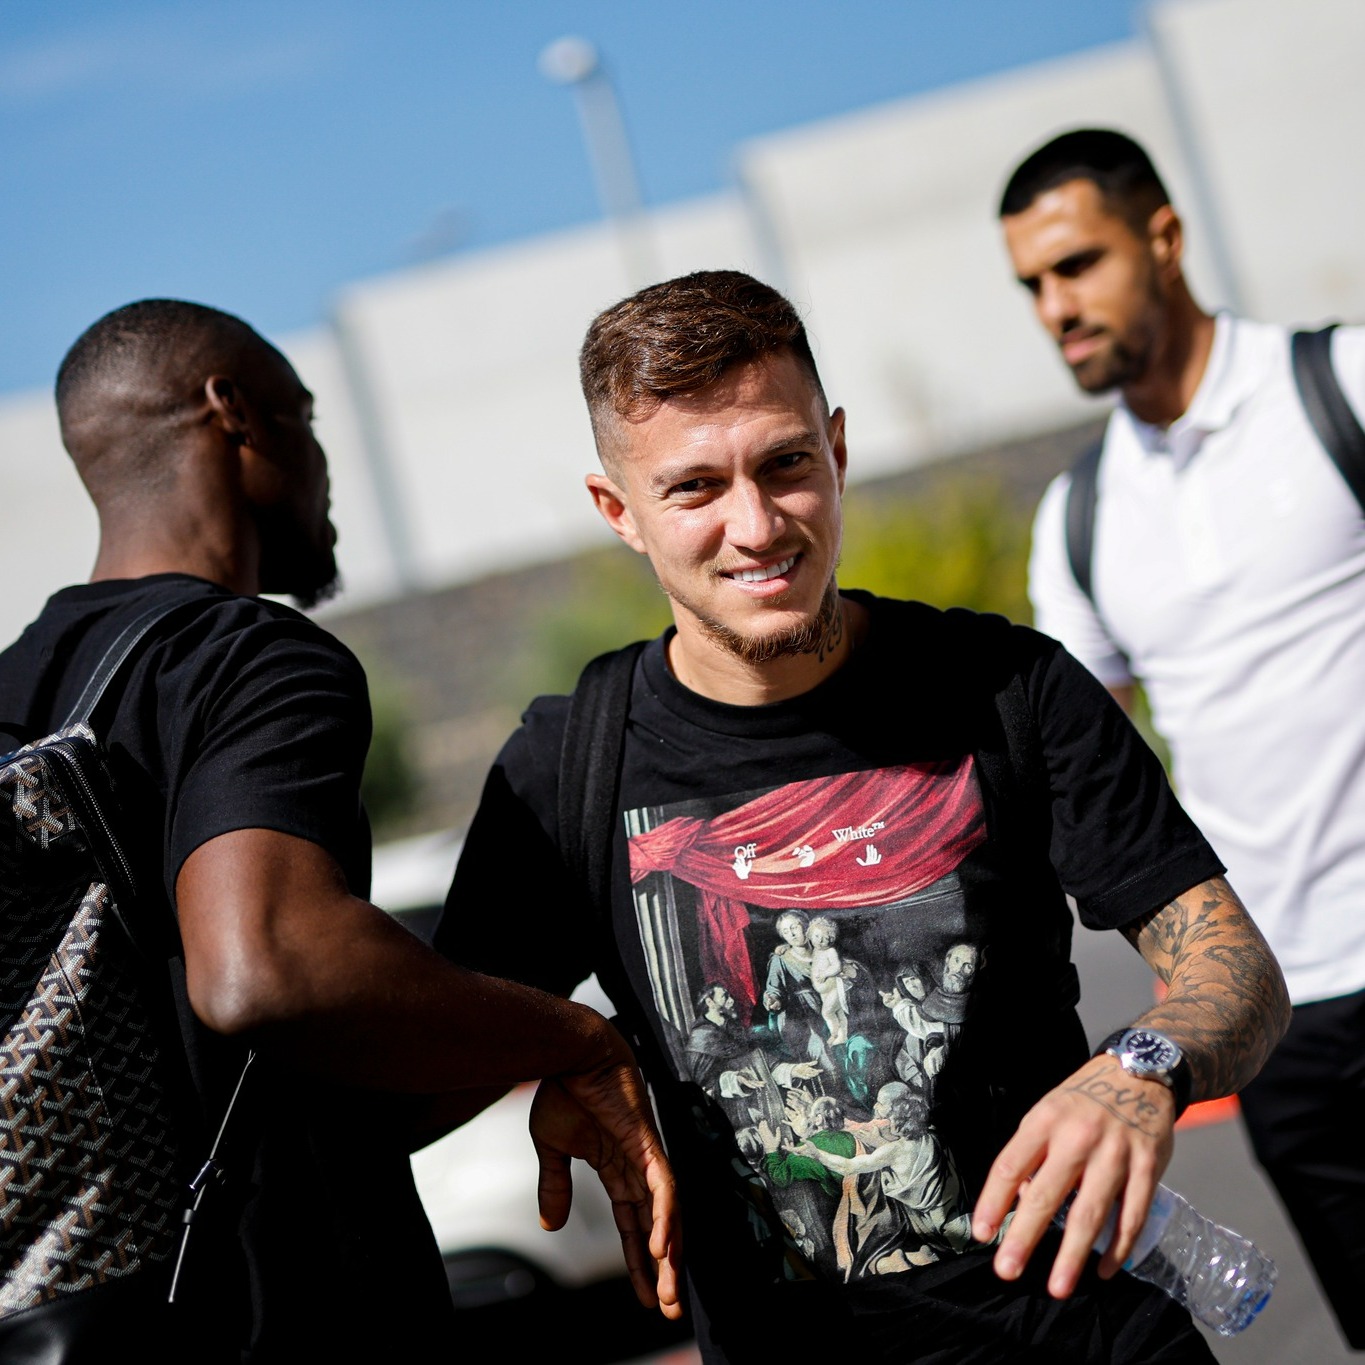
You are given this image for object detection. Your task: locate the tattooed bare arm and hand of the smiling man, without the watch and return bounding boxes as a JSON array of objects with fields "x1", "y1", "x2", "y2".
[{"x1": 972, "y1": 878, "x2": 1290, "y2": 1298}]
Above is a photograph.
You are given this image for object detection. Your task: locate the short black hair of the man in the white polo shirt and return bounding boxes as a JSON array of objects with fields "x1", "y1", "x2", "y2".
[{"x1": 999, "y1": 128, "x2": 1171, "y2": 231}]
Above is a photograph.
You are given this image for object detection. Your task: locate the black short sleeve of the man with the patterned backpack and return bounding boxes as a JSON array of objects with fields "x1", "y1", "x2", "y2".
[{"x1": 160, "y1": 606, "x2": 370, "y2": 895}]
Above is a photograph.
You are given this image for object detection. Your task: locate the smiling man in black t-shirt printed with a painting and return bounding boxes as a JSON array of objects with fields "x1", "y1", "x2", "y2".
[{"x1": 437, "y1": 272, "x2": 1286, "y2": 1365}]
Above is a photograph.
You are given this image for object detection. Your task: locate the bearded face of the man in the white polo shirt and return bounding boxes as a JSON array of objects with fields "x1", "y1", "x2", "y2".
[{"x1": 1002, "y1": 180, "x2": 1179, "y2": 393}]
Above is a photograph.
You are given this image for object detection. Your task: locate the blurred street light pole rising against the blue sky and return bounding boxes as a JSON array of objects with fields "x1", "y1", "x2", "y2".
[{"x1": 539, "y1": 37, "x2": 659, "y2": 289}]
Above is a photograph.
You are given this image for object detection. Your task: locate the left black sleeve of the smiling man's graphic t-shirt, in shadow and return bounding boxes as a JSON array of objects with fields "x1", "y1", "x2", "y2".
[{"x1": 433, "y1": 698, "x2": 595, "y2": 995}]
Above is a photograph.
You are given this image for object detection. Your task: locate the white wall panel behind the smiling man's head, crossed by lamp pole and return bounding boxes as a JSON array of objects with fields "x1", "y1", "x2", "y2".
[{"x1": 326, "y1": 195, "x2": 758, "y2": 597}]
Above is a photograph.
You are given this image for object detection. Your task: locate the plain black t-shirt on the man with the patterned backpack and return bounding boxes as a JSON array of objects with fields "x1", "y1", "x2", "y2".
[{"x1": 0, "y1": 575, "x2": 449, "y2": 1360}]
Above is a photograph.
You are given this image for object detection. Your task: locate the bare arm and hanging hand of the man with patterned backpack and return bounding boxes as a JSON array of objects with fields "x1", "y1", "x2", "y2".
[{"x1": 176, "y1": 830, "x2": 683, "y2": 1317}]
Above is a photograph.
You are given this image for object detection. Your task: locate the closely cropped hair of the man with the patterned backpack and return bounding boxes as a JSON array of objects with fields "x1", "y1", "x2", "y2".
[{"x1": 56, "y1": 299, "x2": 269, "y2": 416}]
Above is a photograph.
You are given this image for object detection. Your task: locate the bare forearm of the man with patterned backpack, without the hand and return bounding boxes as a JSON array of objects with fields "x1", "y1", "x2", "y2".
[{"x1": 176, "y1": 830, "x2": 631, "y2": 1093}]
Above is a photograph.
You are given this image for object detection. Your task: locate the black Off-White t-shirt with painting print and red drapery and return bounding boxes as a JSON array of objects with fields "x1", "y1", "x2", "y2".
[{"x1": 437, "y1": 594, "x2": 1222, "y2": 1361}]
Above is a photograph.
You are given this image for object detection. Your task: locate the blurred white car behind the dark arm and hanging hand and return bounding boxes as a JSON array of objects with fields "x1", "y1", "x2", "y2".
[{"x1": 371, "y1": 833, "x2": 687, "y2": 1362}]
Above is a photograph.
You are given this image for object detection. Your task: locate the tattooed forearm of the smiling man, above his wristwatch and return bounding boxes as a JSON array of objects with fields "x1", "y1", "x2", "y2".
[{"x1": 1122, "y1": 876, "x2": 1289, "y2": 1099}]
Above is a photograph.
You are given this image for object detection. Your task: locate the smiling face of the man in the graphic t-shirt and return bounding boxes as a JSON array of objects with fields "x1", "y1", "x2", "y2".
[{"x1": 588, "y1": 351, "x2": 846, "y2": 693}]
